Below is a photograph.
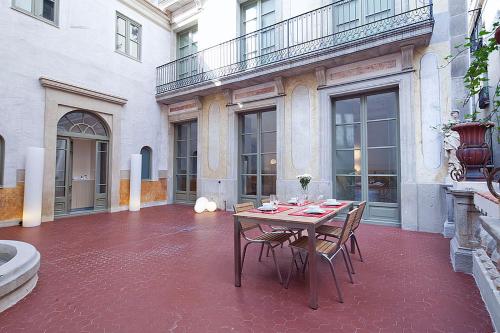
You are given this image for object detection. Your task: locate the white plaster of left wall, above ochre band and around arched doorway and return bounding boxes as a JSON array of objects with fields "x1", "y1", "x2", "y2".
[{"x1": 0, "y1": 0, "x2": 171, "y2": 187}]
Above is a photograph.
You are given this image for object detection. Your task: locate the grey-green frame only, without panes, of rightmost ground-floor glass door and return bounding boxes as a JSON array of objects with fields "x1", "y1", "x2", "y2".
[{"x1": 331, "y1": 88, "x2": 401, "y2": 225}]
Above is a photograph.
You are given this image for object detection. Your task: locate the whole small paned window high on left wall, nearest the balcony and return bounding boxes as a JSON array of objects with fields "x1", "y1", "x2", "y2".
[{"x1": 115, "y1": 13, "x2": 142, "y2": 60}]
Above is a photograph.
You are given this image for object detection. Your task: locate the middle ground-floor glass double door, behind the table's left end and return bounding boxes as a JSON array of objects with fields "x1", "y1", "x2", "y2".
[{"x1": 238, "y1": 110, "x2": 277, "y2": 205}]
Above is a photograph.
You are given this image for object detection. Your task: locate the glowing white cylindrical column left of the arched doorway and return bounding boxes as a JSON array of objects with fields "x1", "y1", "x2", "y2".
[{"x1": 23, "y1": 147, "x2": 45, "y2": 227}]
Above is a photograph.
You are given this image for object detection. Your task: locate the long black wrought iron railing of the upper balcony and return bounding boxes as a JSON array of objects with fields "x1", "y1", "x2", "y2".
[{"x1": 156, "y1": 0, "x2": 433, "y2": 94}]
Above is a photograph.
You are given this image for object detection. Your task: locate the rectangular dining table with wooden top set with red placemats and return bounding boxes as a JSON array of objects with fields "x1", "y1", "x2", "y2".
[{"x1": 233, "y1": 200, "x2": 353, "y2": 310}]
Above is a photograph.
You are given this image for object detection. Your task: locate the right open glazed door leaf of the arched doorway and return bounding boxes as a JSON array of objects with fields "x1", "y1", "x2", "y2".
[{"x1": 94, "y1": 140, "x2": 109, "y2": 210}]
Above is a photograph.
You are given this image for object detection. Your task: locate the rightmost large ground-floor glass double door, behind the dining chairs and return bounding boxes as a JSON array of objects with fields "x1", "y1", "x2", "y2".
[{"x1": 333, "y1": 91, "x2": 400, "y2": 224}]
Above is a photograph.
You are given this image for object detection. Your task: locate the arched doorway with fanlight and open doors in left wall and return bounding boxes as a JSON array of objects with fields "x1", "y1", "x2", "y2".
[{"x1": 54, "y1": 111, "x2": 110, "y2": 216}]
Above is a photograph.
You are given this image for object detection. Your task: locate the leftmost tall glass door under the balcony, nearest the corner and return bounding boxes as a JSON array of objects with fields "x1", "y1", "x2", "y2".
[{"x1": 174, "y1": 120, "x2": 198, "y2": 204}]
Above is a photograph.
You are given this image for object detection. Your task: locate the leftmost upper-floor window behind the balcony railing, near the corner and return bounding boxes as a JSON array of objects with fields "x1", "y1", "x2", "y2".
[{"x1": 177, "y1": 25, "x2": 198, "y2": 79}]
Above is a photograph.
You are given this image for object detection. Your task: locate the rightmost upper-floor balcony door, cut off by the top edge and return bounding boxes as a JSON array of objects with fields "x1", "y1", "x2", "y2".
[{"x1": 333, "y1": 0, "x2": 394, "y2": 33}]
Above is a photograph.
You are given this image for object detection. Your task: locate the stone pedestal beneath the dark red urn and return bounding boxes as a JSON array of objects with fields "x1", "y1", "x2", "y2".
[{"x1": 450, "y1": 189, "x2": 480, "y2": 274}]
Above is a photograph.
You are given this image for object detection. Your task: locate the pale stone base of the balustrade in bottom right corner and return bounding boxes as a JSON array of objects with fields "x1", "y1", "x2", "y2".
[{"x1": 473, "y1": 250, "x2": 500, "y2": 332}]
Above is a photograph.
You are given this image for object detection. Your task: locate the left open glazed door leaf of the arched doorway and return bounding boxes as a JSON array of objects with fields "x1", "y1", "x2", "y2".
[{"x1": 54, "y1": 136, "x2": 72, "y2": 216}]
